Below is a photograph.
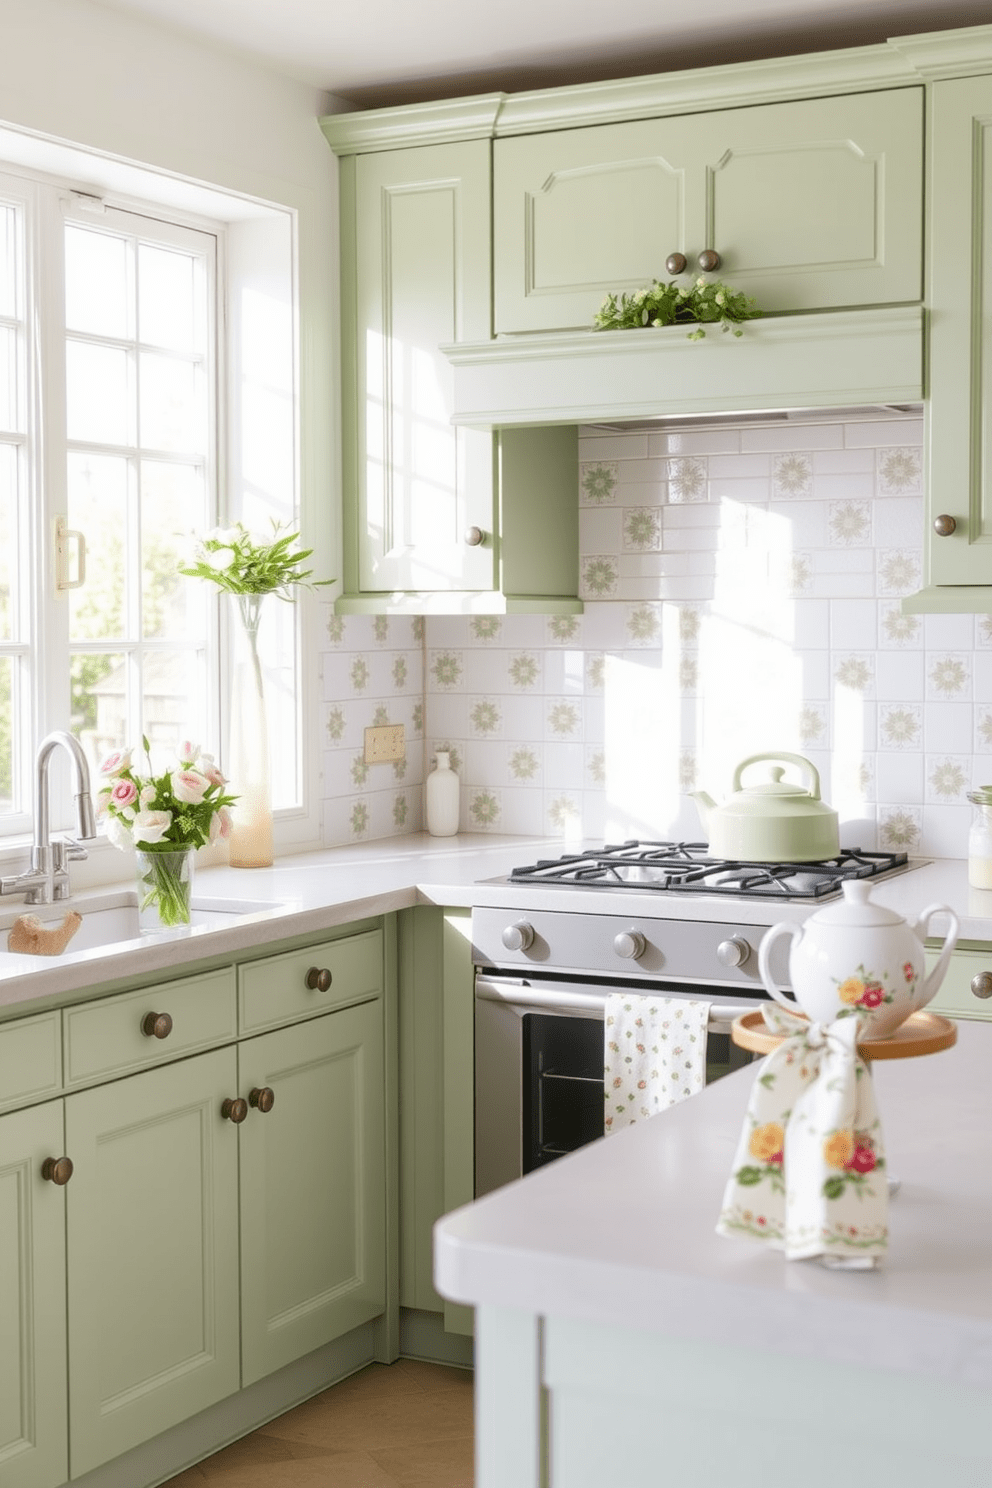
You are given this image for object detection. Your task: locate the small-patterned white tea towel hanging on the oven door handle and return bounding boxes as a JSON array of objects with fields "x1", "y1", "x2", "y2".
[{"x1": 602, "y1": 992, "x2": 709, "y2": 1134}]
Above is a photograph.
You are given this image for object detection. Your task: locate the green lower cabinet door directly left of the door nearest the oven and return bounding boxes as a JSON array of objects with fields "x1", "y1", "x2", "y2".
[{"x1": 65, "y1": 1048, "x2": 238, "y2": 1478}]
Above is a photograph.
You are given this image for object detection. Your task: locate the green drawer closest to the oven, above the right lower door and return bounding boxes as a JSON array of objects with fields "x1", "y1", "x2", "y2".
[{"x1": 238, "y1": 930, "x2": 382, "y2": 1033}]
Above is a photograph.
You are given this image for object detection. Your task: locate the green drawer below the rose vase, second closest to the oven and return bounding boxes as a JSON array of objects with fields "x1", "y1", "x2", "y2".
[{"x1": 62, "y1": 966, "x2": 236, "y2": 1086}]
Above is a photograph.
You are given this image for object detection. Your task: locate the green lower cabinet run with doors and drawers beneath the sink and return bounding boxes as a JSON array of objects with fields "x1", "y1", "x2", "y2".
[{"x1": 0, "y1": 930, "x2": 388, "y2": 1488}]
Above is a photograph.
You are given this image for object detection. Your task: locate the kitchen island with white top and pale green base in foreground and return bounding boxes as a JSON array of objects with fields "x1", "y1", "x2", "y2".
[{"x1": 434, "y1": 1022, "x2": 992, "y2": 1488}]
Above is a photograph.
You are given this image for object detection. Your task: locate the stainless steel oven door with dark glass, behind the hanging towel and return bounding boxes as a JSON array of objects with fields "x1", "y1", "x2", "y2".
[{"x1": 474, "y1": 972, "x2": 751, "y2": 1198}]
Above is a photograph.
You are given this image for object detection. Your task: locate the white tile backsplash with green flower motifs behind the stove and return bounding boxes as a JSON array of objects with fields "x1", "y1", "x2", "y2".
[{"x1": 321, "y1": 417, "x2": 975, "y2": 857}]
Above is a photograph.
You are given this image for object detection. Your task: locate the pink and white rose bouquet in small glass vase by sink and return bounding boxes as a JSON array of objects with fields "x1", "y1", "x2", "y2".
[{"x1": 97, "y1": 738, "x2": 238, "y2": 926}]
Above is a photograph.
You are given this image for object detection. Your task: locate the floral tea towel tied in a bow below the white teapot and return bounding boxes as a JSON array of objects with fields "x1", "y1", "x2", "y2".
[{"x1": 717, "y1": 1006, "x2": 888, "y2": 1263}]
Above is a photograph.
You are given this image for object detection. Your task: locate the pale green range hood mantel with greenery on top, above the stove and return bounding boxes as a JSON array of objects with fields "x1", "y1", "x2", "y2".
[{"x1": 442, "y1": 305, "x2": 924, "y2": 429}]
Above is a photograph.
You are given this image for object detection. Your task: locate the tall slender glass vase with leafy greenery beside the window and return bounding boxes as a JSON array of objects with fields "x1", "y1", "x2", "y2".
[{"x1": 178, "y1": 522, "x2": 332, "y2": 868}]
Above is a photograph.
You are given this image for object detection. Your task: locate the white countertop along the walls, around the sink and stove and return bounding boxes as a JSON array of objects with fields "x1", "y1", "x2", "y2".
[{"x1": 0, "y1": 833, "x2": 992, "y2": 1016}]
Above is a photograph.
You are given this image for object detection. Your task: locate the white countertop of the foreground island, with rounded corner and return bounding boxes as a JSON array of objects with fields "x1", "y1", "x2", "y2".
[{"x1": 434, "y1": 1022, "x2": 992, "y2": 1388}]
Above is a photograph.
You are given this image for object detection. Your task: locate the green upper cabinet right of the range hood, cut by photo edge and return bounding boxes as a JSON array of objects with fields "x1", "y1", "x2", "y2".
[{"x1": 903, "y1": 77, "x2": 992, "y2": 613}]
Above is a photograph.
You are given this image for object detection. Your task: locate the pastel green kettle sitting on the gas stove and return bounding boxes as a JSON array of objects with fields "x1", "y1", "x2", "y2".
[{"x1": 692, "y1": 753, "x2": 840, "y2": 863}]
